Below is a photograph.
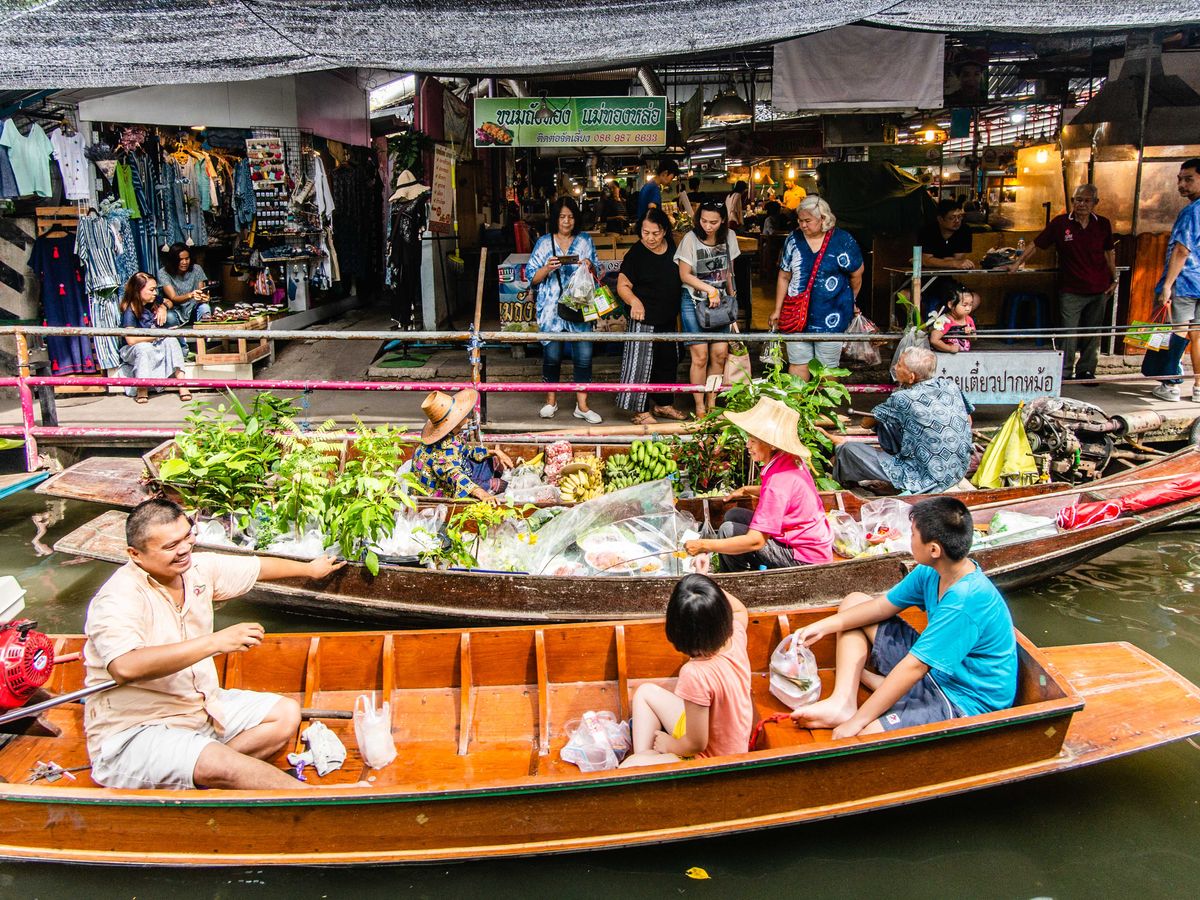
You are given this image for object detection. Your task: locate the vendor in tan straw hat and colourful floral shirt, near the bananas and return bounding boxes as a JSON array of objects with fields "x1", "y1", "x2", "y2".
[{"x1": 413, "y1": 388, "x2": 512, "y2": 500}]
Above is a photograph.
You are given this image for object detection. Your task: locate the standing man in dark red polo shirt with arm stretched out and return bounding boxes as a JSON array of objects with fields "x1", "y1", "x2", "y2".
[{"x1": 1009, "y1": 185, "x2": 1117, "y2": 379}]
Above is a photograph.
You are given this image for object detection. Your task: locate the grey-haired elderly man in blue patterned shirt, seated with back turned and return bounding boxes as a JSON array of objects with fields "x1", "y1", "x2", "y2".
[{"x1": 833, "y1": 347, "x2": 974, "y2": 493}]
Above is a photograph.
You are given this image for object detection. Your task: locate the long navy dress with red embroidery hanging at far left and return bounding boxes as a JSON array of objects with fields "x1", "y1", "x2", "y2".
[{"x1": 29, "y1": 234, "x2": 96, "y2": 376}]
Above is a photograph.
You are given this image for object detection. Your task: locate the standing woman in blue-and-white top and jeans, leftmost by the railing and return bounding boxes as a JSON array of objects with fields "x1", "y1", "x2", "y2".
[{"x1": 526, "y1": 197, "x2": 604, "y2": 425}]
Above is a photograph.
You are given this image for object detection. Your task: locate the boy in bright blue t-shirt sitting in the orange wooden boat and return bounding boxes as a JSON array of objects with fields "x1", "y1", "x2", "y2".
[{"x1": 792, "y1": 497, "x2": 1016, "y2": 739}]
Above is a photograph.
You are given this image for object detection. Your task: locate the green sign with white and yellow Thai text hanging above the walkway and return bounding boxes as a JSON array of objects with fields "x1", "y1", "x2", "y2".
[{"x1": 475, "y1": 97, "x2": 667, "y2": 148}]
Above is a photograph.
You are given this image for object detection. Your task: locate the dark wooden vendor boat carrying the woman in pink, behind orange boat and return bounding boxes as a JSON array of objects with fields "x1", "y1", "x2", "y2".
[{"x1": 54, "y1": 448, "x2": 1200, "y2": 623}]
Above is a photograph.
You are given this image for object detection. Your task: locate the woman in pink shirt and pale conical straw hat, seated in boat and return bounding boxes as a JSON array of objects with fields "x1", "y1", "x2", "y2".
[{"x1": 684, "y1": 397, "x2": 833, "y2": 572}]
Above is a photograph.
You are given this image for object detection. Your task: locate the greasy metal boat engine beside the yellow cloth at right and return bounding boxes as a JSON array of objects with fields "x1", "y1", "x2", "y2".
[{"x1": 1025, "y1": 397, "x2": 1122, "y2": 482}]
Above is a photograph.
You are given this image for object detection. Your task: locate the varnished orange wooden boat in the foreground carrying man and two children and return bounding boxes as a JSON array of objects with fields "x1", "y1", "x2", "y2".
[{"x1": 0, "y1": 610, "x2": 1200, "y2": 866}]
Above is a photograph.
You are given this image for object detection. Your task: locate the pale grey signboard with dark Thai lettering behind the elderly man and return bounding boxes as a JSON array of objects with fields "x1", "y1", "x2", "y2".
[{"x1": 934, "y1": 350, "x2": 1062, "y2": 404}]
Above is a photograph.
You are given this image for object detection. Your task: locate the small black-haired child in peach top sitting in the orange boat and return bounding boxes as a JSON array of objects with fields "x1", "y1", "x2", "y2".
[{"x1": 622, "y1": 575, "x2": 754, "y2": 767}]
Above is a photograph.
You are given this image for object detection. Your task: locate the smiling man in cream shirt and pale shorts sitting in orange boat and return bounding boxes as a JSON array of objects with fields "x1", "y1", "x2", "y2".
[{"x1": 84, "y1": 499, "x2": 346, "y2": 788}]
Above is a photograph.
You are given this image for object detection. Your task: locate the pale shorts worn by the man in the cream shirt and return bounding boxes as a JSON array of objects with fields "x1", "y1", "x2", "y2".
[{"x1": 91, "y1": 690, "x2": 282, "y2": 790}]
